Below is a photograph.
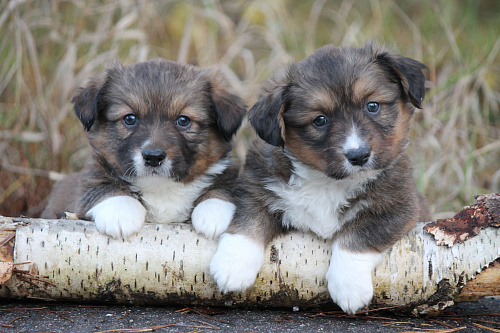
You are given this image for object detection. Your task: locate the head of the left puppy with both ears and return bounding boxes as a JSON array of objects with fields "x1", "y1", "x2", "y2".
[{"x1": 73, "y1": 59, "x2": 245, "y2": 182}]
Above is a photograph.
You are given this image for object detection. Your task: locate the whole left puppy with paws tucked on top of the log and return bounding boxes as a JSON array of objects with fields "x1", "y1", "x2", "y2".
[{"x1": 42, "y1": 59, "x2": 246, "y2": 239}]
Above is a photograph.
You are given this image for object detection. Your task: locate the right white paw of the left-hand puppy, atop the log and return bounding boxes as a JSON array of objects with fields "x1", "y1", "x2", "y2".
[{"x1": 191, "y1": 198, "x2": 236, "y2": 238}]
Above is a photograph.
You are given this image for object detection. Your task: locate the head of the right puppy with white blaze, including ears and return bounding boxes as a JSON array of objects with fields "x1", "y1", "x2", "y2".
[{"x1": 249, "y1": 44, "x2": 425, "y2": 179}]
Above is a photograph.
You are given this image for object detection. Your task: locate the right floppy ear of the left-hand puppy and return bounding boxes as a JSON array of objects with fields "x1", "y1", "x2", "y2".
[{"x1": 209, "y1": 71, "x2": 247, "y2": 142}]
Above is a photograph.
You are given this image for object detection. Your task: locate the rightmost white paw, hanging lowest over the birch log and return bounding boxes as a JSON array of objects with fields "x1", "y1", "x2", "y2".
[{"x1": 326, "y1": 243, "x2": 384, "y2": 314}]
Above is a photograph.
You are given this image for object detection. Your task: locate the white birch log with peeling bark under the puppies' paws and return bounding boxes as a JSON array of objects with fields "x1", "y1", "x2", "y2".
[{"x1": 0, "y1": 211, "x2": 500, "y2": 313}]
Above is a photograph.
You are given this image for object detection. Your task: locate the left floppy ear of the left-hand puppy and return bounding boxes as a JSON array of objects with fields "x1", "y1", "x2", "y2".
[{"x1": 71, "y1": 74, "x2": 107, "y2": 132}]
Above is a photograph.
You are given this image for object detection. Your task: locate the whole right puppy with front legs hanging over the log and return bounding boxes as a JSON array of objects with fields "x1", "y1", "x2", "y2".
[{"x1": 210, "y1": 44, "x2": 428, "y2": 314}]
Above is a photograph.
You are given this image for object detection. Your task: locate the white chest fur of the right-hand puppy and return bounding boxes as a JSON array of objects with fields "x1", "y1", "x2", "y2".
[{"x1": 266, "y1": 161, "x2": 379, "y2": 238}]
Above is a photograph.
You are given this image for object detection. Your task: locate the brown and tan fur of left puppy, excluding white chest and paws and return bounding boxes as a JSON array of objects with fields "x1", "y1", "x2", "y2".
[{"x1": 42, "y1": 59, "x2": 245, "y2": 226}]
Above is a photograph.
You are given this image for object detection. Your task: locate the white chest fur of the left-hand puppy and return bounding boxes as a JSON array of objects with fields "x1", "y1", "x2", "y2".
[{"x1": 133, "y1": 160, "x2": 229, "y2": 223}]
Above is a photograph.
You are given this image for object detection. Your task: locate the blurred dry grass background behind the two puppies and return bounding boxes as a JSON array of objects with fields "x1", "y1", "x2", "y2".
[{"x1": 0, "y1": 0, "x2": 500, "y2": 218}]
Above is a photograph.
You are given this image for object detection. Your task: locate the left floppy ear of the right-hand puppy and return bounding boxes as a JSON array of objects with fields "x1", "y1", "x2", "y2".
[{"x1": 248, "y1": 69, "x2": 288, "y2": 147}]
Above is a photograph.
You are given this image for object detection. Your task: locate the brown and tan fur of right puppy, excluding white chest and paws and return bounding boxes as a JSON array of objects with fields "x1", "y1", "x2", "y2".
[{"x1": 230, "y1": 40, "x2": 429, "y2": 251}]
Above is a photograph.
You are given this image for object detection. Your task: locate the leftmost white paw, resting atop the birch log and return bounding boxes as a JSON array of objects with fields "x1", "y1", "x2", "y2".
[{"x1": 87, "y1": 195, "x2": 146, "y2": 240}]
